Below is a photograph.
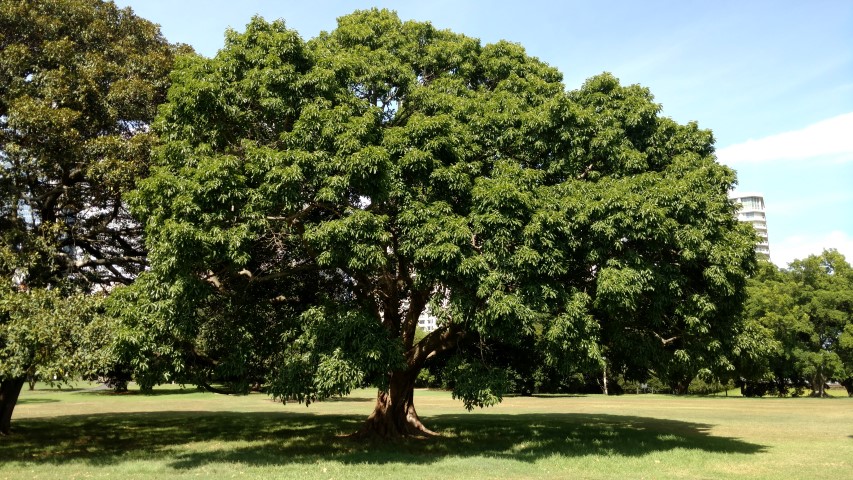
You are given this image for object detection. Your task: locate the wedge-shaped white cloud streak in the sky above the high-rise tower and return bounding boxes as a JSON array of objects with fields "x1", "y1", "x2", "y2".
[{"x1": 717, "y1": 112, "x2": 853, "y2": 165}]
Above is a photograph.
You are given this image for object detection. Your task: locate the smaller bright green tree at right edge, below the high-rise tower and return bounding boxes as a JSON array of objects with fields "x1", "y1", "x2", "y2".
[{"x1": 741, "y1": 250, "x2": 853, "y2": 396}]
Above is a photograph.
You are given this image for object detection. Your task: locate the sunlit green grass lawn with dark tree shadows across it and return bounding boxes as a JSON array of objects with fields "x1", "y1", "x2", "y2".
[{"x1": 0, "y1": 384, "x2": 853, "y2": 480}]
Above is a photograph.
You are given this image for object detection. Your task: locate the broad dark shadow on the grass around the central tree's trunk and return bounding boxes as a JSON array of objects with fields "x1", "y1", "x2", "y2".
[{"x1": 0, "y1": 412, "x2": 765, "y2": 470}]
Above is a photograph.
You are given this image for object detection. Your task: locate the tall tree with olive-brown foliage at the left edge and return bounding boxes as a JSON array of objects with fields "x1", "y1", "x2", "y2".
[{"x1": 0, "y1": 0, "x2": 173, "y2": 436}]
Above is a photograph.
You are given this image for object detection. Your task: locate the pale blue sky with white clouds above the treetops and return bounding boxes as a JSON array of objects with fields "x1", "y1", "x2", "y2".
[{"x1": 116, "y1": 0, "x2": 853, "y2": 266}]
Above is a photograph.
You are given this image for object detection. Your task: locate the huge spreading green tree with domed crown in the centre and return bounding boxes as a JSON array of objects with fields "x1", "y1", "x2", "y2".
[{"x1": 131, "y1": 10, "x2": 754, "y2": 436}]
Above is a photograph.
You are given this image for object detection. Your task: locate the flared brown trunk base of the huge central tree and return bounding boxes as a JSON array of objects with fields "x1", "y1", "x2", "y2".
[{"x1": 353, "y1": 369, "x2": 436, "y2": 439}]
